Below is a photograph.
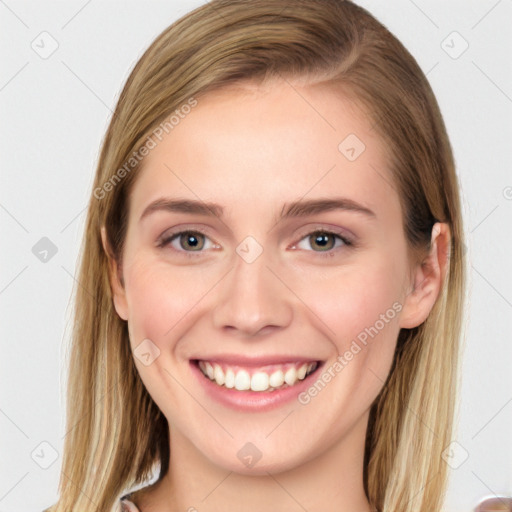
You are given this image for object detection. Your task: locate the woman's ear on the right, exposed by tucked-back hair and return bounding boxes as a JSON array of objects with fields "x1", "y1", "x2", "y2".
[{"x1": 399, "y1": 222, "x2": 451, "y2": 329}]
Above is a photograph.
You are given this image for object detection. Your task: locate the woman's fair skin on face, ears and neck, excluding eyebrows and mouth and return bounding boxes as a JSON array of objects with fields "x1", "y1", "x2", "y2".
[{"x1": 102, "y1": 80, "x2": 449, "y2": 512}]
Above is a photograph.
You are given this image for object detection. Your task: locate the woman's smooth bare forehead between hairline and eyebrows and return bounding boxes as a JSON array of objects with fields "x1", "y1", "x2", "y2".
[{"x1": 127, "y1": 80, "x2": 398, "y2": 220}]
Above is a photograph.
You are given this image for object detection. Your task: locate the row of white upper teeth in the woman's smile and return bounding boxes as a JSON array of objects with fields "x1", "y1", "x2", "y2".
[{"x1": 199, "y1": 361, "x2": 317, "y2": 391}]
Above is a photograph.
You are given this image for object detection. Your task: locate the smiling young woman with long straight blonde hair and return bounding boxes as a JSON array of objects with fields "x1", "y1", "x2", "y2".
[{"x1": 49, "y1": 0, "x2": 465, "y2": 512}]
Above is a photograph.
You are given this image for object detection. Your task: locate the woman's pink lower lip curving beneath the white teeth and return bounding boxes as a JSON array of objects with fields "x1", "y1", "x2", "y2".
[{"x1": 190, "y1": 361, "x2": 322, "y2": 412}]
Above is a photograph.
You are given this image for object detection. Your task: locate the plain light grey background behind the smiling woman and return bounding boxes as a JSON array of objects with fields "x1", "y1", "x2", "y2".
[{"x1": 0, "y1": 0, "x2": 512, "y2": 512}]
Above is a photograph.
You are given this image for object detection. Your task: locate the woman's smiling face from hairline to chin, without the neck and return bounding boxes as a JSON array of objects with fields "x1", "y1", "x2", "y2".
[{"x1": 103, "y1": 77, "x2": 431, "y2": 474}]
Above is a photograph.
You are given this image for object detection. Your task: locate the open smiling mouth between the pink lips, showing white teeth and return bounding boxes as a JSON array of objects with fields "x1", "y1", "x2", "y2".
[{"x1": 191, "y1": 359, "x2": 322, "y2": 393}]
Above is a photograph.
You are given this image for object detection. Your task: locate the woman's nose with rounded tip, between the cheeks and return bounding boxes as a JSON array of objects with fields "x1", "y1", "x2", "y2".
[{"x1": 213, "y1": 245, "x2": 293, "y2": 337}]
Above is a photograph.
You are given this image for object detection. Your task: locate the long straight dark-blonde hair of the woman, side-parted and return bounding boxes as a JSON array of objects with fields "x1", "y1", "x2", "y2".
[{"x1": 48, "y1": 0, "x2": 465, "y2": 512}]
